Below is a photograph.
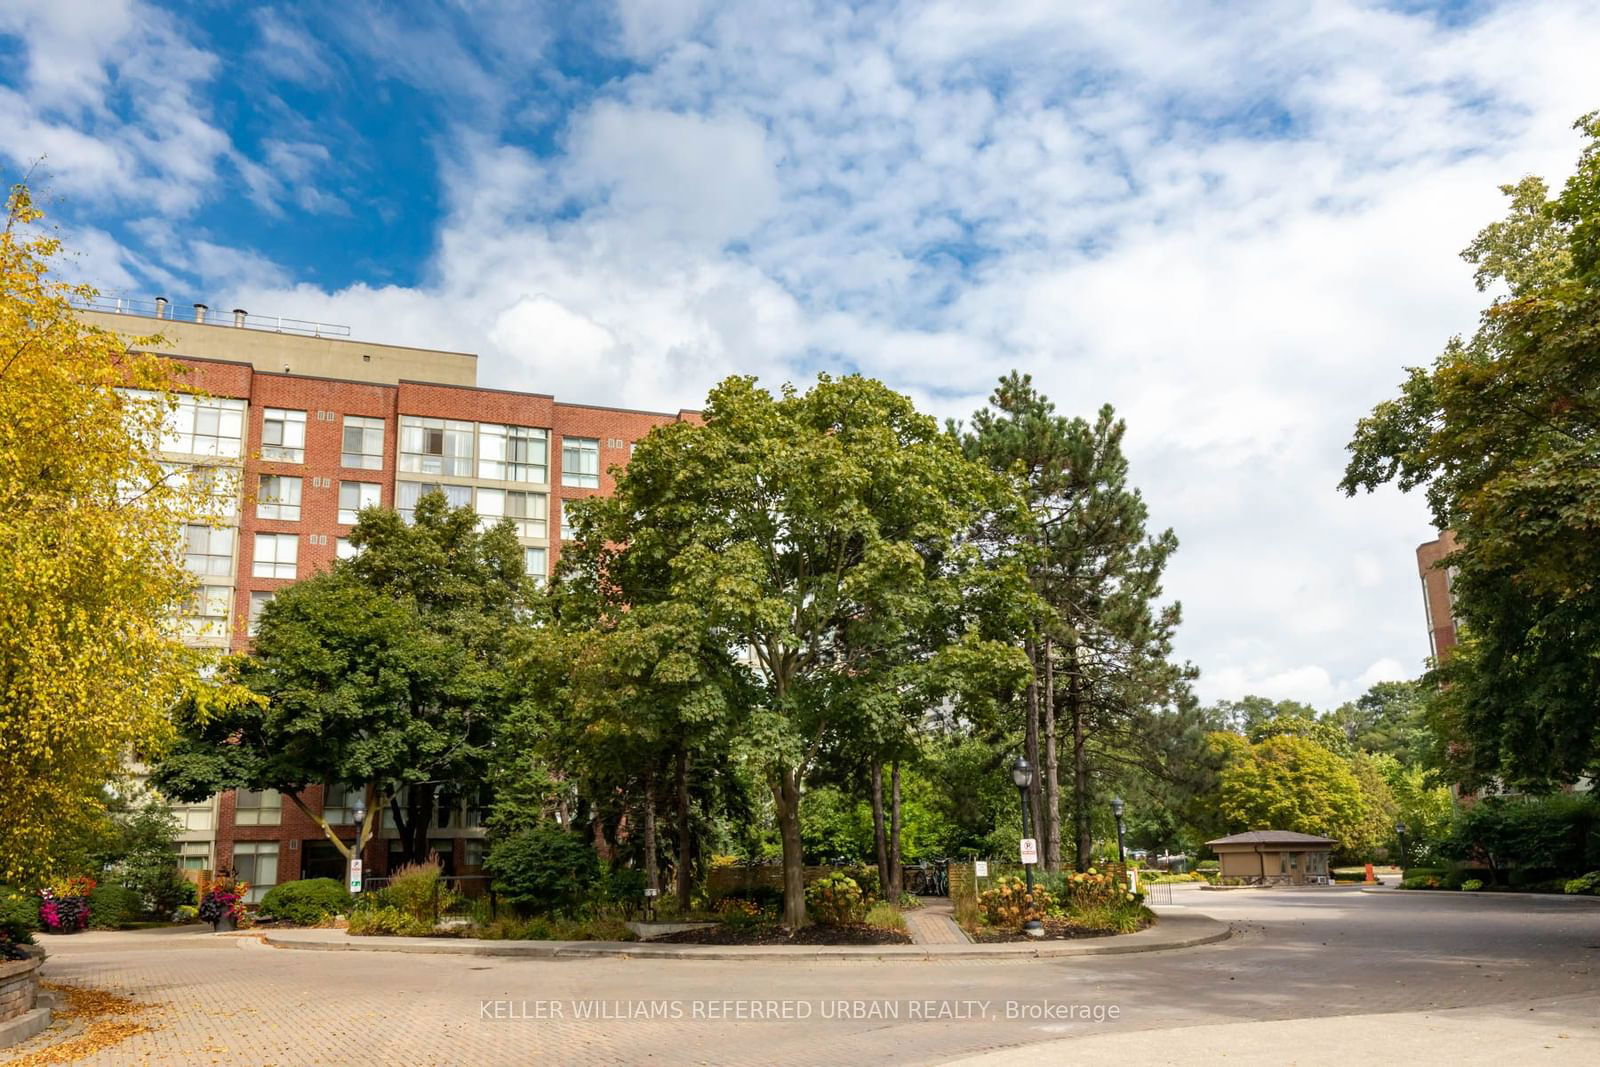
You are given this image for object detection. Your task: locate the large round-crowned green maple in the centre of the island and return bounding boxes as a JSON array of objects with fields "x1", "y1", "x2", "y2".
[{"x1": 590, "y1": 376, "x2": 1010, "y2": 926}]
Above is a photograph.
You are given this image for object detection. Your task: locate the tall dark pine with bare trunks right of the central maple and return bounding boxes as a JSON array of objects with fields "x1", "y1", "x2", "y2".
[{"x1": 963, "y1": 373, "x2": 1194, "y2": 870}]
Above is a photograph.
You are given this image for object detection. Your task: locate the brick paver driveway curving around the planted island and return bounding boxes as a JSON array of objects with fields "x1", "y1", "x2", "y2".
[{"x1": 9, "y1": 889, "x2": 1600, "y2": 1067}]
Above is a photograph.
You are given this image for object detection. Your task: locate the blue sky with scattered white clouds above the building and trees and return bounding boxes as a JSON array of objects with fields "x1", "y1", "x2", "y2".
[{"x1": 0, "y1": 0, "x2": 1600, "y2": 705}]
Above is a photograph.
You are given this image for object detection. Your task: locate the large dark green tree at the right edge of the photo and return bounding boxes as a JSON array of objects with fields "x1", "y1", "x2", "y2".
[{"x1": 1341, "y1": 112, "x2": 1600, "y2": 785}]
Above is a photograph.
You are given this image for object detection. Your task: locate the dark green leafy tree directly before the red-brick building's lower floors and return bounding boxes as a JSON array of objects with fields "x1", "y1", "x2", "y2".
[{"x1": 152, "y1": 493, "x2": 531, "y2": 862}]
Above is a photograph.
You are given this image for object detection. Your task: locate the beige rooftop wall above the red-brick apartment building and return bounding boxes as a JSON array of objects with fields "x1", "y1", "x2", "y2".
[{"x1": 78, "y1": 310, "x2": 478, "y2": 386}]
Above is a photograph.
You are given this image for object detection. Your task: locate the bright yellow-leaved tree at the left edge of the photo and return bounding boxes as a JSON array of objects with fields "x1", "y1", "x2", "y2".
[{"x1": 0, "y1": 186, "x2": 225, "y2": 885}]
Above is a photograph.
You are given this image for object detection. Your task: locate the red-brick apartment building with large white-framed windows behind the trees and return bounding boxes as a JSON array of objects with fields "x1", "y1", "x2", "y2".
[{"x1": 83, "y1": 299, "x2": 696, "y2": 899}]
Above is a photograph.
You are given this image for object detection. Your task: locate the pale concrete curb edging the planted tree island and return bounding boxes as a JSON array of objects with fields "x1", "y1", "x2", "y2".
[{"x1": 256, "y1": 915, "x2": 1232, "y2": 963}]
